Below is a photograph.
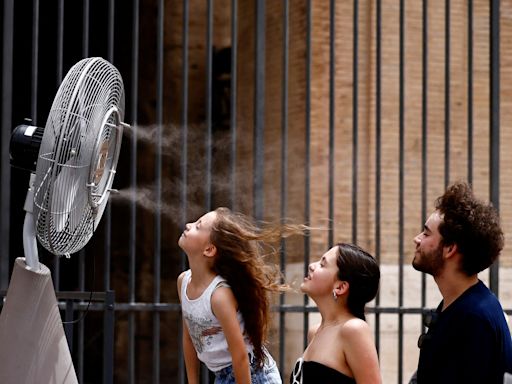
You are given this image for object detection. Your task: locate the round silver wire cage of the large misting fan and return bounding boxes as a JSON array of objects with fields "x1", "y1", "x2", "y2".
[{"x1": 34, "y1": 57, "x2": 124, "y2": 255}]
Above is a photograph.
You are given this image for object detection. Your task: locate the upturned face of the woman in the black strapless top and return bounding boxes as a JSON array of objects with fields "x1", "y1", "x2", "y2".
[{"x1": 300, "y1": 246, "x2": 338, "y2": 298}]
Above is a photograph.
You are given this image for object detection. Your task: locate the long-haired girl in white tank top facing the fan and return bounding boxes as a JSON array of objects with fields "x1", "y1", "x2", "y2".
[{"x1": 178, "y1": 208, "x2": 299, "y2": 384}]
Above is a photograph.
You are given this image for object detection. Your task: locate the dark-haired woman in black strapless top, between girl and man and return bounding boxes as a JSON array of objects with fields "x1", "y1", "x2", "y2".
[{"x1": 290, "y1": 244, "x2": 381, "y2": 384}]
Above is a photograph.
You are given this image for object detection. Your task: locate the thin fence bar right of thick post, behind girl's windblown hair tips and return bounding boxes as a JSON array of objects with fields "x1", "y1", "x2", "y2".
[{"x1": 279, "y1": 0, "x2": 290, "y2": 369}]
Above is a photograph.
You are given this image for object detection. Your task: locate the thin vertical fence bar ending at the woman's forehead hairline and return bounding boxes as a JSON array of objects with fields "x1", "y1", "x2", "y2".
[{"x1": 327, "y1": 0, "x2": 336, "y2": 248}]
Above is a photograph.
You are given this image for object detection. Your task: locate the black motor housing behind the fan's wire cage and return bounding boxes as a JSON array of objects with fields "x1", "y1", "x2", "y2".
[{"x1": 9, "y1": 124, "x2": 44, "y2": 172}]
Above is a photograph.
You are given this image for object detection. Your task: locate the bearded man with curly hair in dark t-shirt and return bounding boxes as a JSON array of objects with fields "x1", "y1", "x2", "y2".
[{"x1": 412, "y1": 183, "x2": 512, "y2": 384}]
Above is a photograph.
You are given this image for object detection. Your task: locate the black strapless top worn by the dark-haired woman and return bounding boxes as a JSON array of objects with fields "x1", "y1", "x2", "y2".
[{"x1": 290, "y1": 358, "x2": 356, "y2": 384}]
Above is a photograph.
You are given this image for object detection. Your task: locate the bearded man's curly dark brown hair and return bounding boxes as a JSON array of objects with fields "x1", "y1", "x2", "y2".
[{"x1": 436, "y1": 183, "x2": 504, "y2": 276}]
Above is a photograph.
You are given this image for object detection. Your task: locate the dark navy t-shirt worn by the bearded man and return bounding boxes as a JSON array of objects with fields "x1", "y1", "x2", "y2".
[{"x1": 417, "y1": 281, "x2": 512, "y2": 384}]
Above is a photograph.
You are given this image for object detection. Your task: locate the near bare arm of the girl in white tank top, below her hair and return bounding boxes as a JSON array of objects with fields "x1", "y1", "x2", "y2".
[{"x1": 212, "y1": 287, "x2": 251, "y2": 384}]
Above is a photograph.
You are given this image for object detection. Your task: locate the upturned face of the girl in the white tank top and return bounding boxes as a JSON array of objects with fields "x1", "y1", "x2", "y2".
[{"x1": 178, "y1": 211, "x2": 217, "y2": 256}]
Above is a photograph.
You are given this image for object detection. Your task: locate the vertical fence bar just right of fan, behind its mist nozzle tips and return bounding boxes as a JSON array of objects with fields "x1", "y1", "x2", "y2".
[{"x1": 128, "y1": 0, "x2": 139, "y2": 384}]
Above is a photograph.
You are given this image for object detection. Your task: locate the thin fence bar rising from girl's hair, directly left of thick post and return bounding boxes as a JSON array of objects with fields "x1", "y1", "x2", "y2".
[{"x1": 230, "y1": 0, "x2": 238, "y2": 209}]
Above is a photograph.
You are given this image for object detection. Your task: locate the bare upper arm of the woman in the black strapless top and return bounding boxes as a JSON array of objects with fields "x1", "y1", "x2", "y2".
[{"x1": 341, "y1": 319, "x2": 382, "y2": 384}]
